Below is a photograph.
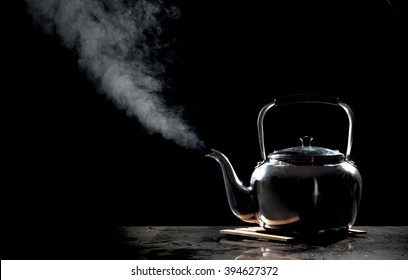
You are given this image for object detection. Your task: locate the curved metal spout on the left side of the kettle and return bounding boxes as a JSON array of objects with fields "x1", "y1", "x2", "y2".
[{"x1": 206, "y1": 149, "x2": 257, "y2": 223}]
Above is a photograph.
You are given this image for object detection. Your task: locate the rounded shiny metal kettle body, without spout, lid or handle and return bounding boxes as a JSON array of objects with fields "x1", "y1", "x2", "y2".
[{"x1": 251, "y1": 159, "x2": 362, "y2": 232}]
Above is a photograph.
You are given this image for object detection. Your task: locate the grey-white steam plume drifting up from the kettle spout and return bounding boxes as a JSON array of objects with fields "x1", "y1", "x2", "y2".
[{"x1": 26, "y1": 0, "x2": 203, "y2": 148}]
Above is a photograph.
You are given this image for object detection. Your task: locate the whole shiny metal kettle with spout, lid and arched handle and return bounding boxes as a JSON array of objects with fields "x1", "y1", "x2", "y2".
[{"x1": 207, "y1": 96, "x2": 362, "y2": 233}]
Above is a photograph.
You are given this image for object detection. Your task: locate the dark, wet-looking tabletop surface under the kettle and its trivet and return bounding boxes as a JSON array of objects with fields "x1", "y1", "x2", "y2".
[{"x1": 6, "y1": 226, "x2": 408, "y2": 260}]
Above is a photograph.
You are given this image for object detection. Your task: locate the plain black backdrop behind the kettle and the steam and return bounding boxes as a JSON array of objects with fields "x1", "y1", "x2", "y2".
[{"x1": 1, "y1": 0, "x2": 408, "y2": 258}]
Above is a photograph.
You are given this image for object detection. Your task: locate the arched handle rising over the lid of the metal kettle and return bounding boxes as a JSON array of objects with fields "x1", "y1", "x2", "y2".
[{"x1": 258, "y1": 95, "x2": 354, "y2": 160}]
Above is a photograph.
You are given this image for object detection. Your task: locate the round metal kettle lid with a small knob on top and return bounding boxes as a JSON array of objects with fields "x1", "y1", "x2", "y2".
[{"x1": 268, "y1": 136, "x2": 345, "y2": 165}]
